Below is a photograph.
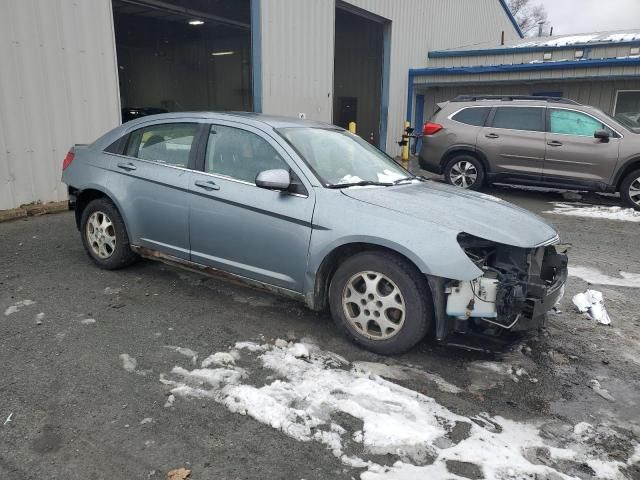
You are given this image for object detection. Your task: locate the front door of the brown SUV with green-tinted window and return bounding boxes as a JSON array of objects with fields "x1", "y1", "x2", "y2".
[{"x1": 543, "y1": 108, "x2": 621, "y2": 186}]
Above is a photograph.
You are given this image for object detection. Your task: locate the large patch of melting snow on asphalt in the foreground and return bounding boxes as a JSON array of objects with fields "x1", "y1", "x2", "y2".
[{"x1": 160, "y1": 340, "x2": 626, "y2": 480}]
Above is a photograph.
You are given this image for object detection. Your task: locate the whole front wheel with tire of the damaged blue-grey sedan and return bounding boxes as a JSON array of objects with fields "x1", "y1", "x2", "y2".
[{"x1": 329, "y1": 252, "x2": 433, "y2": 355}]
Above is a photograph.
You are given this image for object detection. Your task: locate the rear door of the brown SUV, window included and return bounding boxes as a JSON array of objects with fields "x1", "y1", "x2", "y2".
[{"x1": 476, "y1": 106, "x2": 546, "y2": 179}]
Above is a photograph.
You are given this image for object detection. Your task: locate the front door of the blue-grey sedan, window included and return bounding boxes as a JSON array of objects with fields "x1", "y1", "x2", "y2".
[{"x1": 189, "y1": 122, "x2": 314, "y2": 292}]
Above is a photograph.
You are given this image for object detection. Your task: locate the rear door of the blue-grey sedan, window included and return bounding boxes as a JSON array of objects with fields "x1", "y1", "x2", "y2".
[{"x1": 111, "y1": 120, "x2": 201, "y2": 260}]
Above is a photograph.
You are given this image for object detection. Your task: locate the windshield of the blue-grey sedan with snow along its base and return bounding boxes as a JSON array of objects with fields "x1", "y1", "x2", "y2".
[{"x1": 278, "y1": 127, "x2": 414, "y2": 187}]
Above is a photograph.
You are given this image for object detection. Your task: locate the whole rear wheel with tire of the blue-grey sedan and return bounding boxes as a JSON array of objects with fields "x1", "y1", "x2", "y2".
[{"x1": 80, "y1": 198, "x2": 139, "y2": 270}]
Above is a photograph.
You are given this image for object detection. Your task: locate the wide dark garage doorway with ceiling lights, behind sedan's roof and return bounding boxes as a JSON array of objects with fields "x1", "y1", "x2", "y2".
[{"x1": 112, "y1": 0, "x2": 252, "y2": 122}]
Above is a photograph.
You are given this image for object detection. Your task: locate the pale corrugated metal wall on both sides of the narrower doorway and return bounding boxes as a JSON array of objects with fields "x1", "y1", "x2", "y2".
[{"x1": 260, "y1": 0, "x2": 518, "y2": 155}]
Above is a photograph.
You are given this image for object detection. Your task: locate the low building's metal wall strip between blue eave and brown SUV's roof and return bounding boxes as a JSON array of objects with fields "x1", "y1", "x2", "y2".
[{"x1": 417, "y1": 78, "x2": 640, "y2": 119}]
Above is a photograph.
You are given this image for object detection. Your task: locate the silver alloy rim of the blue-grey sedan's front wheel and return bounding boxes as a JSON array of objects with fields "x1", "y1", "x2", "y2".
[{"x1": 342, "y1": 271, "x2": 406, "y2": 340}]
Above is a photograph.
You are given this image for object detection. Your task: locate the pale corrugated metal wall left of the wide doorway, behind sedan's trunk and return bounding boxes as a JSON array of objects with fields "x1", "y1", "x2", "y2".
[{"x1": 0, "y1": 0, "x2": 120, "y2": 210}]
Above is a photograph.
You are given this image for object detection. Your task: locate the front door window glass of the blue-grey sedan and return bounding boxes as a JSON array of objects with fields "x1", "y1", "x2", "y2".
[{"x1": 204, "y1": 125, "x2": 289, "y2": 183}]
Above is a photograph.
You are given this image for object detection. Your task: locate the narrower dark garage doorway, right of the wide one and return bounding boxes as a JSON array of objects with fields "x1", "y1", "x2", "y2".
[{"x1": 333, "y1": 2, "x2": 391, "y2": 148}]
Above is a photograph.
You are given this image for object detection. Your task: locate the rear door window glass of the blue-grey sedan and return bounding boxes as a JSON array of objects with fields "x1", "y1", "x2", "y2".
[{"x1": 126, "y1": 123, "x2": 198, "y2": 167}]
